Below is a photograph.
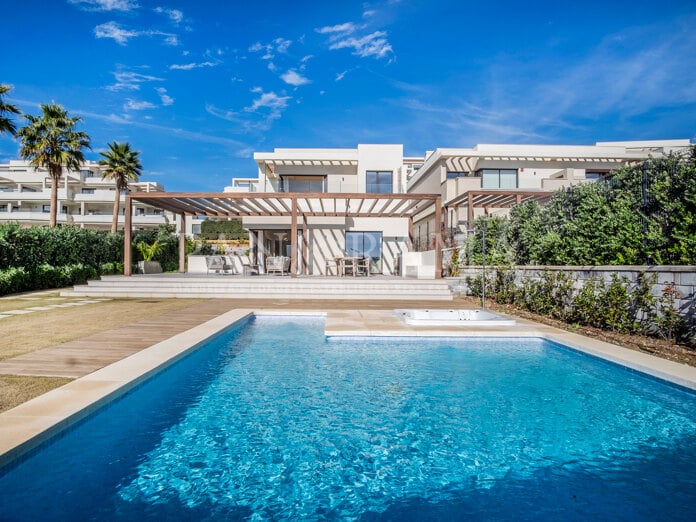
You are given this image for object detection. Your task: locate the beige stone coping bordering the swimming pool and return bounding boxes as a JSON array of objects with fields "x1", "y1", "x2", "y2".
[{"x1": 0, "y1": 309, "x2": 696, "y2": 467}]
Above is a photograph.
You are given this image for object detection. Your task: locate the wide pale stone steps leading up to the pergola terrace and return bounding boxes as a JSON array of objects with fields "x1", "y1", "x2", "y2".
[{"x1": 61, "y1": 274, "x2": 452, "y2": 301}]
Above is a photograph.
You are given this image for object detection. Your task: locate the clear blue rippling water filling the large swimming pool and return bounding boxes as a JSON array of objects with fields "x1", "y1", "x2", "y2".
[{"x1": 0, "y1": 317, "x2": 696, "y2": 520}]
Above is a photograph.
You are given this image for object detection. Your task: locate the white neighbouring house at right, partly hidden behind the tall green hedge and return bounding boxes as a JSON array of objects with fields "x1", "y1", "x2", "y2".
[{"x1": 406, "y1": 139, "x2": 690, "y2": 242}]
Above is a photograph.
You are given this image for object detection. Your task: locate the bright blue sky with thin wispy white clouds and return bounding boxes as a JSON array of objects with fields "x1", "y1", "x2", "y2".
[{"x1": 0, "y1": 0, "x2": 696, "y2": 191}]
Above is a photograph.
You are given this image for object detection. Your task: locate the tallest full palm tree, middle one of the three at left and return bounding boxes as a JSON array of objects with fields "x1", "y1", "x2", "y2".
[{"x1": 17, "y1": 103, "x2": 90, "y2": 227}]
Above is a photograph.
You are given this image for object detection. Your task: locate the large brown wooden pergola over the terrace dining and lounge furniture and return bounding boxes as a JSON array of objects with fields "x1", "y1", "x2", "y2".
[{"x1": 123, "y1": 192, "x2": 442, "y2": 278}]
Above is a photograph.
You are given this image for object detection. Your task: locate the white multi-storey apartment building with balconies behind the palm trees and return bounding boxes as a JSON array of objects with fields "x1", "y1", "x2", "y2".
[{"x1": 0, "y1": 160, "x2": 175, "y2": 230}]
